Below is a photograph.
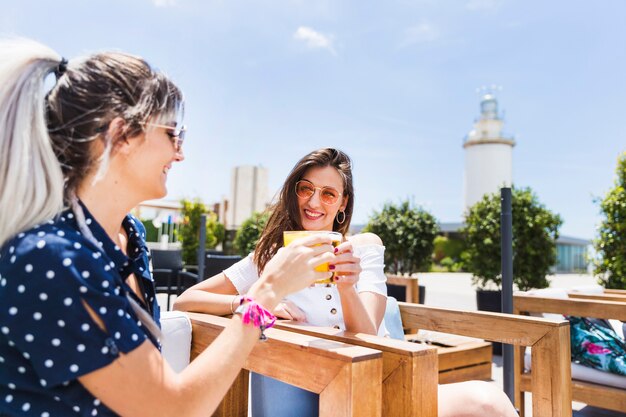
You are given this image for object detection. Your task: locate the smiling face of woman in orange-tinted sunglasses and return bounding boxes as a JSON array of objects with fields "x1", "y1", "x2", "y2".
[{"x1": 294, "y1": 166, "x2": 348, "y2": 230}]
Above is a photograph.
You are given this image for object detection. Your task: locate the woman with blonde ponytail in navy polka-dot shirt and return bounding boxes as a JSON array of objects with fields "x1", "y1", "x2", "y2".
[{"x1": 0, "y1": 39, "x2": 334, "y2": 416}]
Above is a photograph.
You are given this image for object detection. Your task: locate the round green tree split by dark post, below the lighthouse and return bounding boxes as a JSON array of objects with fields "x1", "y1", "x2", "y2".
[{"x1": 463, "y1": 187, "x2": 563, "y2": 291}]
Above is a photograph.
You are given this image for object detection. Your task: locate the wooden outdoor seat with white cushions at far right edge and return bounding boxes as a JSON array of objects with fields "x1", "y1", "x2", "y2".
[{"x1": 513, "y1": 288, "x2": 626, "y2": 416}]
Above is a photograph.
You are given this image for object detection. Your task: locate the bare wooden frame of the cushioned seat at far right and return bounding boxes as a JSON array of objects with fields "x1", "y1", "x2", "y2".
[{"x1": 513, "y1": 293, "x2": 626, "y2": 416}]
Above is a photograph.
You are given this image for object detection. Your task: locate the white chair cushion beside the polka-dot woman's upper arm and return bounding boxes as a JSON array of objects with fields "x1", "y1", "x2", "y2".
[{"x1": 161, "y1": 311, "x2": 191, "y2": 372}]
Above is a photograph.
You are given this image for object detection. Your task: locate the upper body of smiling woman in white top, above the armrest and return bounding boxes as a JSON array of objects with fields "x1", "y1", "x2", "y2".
[{"x1": 174, "y1": 148, "x2": 387, "y2": 334}]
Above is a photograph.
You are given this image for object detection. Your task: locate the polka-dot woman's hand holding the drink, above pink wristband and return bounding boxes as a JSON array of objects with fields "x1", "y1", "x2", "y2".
[{"x1": 248, "y1": 234, "x2": 335, "y2": 309}]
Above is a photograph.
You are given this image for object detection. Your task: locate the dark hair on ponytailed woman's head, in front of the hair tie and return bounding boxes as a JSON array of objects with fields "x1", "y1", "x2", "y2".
[{"x1": 46, "y1": 53, "x2": 183, "y2": 201}]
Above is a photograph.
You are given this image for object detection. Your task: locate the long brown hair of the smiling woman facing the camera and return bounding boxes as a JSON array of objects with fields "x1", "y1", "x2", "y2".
[{"x1": 254, "y1": 148, "x2": 354, "y2": 275}]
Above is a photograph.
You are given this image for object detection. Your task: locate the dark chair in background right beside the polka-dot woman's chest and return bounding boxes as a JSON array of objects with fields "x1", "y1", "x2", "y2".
[{"x1": 150, "y1": 249, "x2": 198, "y2": 310}]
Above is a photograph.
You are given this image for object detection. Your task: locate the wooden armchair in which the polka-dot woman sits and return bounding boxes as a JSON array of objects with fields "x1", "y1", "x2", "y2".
[{"x1": 188, "y1": 313, "x2": 383, "y2": 417}]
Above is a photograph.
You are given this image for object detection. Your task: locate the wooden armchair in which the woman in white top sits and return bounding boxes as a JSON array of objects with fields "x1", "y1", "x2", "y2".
[{"x1": 278, "y1": 303, "x2": 572, "y2": 417}]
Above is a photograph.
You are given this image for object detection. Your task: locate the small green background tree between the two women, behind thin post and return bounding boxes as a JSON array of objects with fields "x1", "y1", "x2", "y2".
[{"x1": 178, "y1": 199, "x2": 224, "y2": 264}]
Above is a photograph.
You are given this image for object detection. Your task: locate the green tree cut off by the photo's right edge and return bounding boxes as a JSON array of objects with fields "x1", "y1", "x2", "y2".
[{"x1": 594, "y1": 152, "x2": 626, "y2": 289}]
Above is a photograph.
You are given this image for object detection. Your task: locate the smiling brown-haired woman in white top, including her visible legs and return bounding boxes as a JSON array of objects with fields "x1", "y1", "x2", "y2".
[{"x1": 175, "y1": 148, "x2": 517, "y2": 417}]
